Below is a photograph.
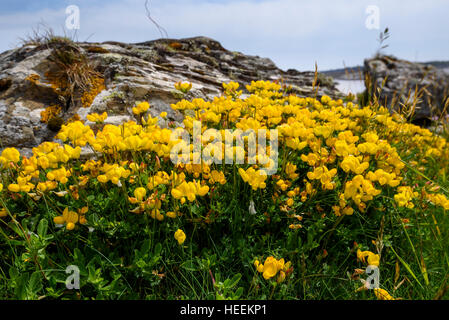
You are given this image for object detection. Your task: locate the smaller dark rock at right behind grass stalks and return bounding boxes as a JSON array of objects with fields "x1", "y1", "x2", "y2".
[{"x1": 365, "y1": 56, "x2": 449, "y2": 124}]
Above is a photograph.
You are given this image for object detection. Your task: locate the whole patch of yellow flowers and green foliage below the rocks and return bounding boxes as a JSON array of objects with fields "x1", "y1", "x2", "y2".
[{"x1": 0, "y1": 81, "x2": 449, "y2": 300}]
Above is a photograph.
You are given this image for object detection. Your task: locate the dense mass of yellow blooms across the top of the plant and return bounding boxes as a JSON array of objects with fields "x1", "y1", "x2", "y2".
[{"x1": 0, "y1": 81, "x2": 449, "y2": 236}]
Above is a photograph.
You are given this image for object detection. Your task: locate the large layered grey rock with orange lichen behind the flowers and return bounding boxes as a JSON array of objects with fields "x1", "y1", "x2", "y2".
[{"x1": 0, "y1": 37, "x2": 342, "y2": 153}]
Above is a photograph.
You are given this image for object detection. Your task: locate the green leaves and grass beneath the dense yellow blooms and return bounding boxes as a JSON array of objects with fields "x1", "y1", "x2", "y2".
[{"x1": 0, "y1": 79, "x2": 449, "y2": 300}]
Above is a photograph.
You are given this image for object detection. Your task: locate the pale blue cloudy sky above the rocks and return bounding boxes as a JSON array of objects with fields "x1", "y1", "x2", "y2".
[{"x1": 0, "y1": 0, "x2": 449, "y2": 71}]
